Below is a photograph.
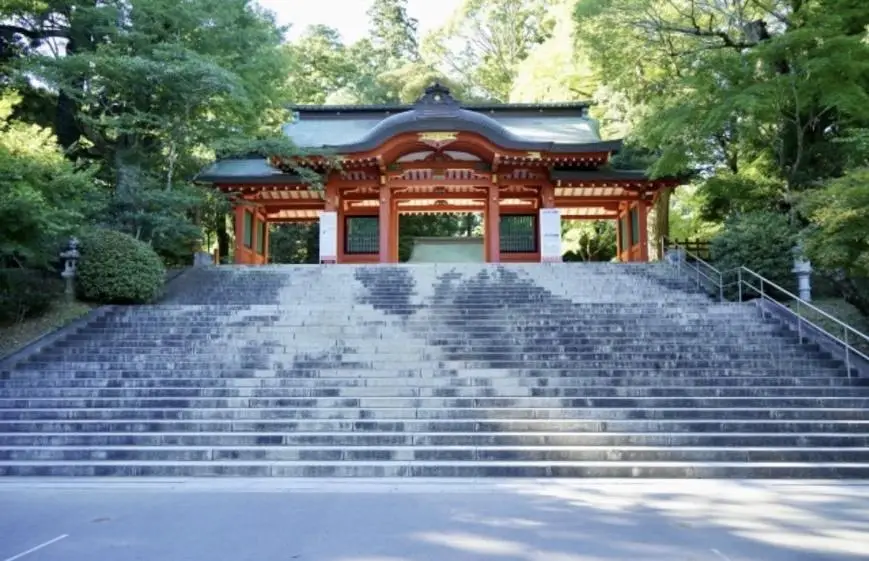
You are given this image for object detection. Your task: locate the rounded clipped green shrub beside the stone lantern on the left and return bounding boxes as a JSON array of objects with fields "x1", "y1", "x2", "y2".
[{"x1": 76, "y1": 230, "x2": 166, "y2": 304}]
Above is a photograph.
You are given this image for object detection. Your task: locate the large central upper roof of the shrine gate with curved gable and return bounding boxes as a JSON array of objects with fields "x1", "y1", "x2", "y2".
[{"x1": 284, "y1": 84, "x2": 621, "y2": 153}]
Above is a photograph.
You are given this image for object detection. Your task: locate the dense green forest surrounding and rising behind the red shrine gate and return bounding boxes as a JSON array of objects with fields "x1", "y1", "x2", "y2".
[{"x1": 0, "y1": 0, "x2": 869, "y2": 336}]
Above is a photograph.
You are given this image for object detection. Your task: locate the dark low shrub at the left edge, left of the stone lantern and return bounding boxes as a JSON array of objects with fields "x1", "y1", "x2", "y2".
[{"x1": 0, "y1": 269, "x2": 63, "y2": 324}]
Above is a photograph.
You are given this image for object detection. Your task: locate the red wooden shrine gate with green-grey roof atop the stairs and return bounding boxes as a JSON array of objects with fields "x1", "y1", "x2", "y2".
[{"x1": 197, "y1": 84, "x2": 676, "y2": 264}]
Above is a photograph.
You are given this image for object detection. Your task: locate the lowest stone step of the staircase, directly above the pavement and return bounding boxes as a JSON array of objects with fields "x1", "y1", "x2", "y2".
[{"x1": 0, "y1": 460, "x2": 869, "y2": 479}]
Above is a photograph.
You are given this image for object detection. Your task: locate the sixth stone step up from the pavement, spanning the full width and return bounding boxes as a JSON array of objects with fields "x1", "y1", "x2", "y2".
[{"x1": 0, "y1": 396, "x2": 869, "y2": 410}]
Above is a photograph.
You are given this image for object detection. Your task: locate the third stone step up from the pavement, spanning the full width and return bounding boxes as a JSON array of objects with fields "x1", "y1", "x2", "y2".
[{"x1": 0, "y1": 432, "x2": 869, "y2": 448}]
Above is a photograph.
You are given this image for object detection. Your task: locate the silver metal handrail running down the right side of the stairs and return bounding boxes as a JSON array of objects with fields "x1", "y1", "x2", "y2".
[{"x1": 662, "y1": 236, "x2": 869, "y2": 378}]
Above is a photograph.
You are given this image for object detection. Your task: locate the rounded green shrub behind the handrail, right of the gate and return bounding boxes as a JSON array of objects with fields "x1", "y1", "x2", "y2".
[{"x1": 709, "y1": 212, "x2": 797, "y2": 298}]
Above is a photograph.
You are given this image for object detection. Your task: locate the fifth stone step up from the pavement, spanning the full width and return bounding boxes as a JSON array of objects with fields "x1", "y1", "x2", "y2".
[{"x1": 0, "y1": 406, "x2": 869, "y2": 422}]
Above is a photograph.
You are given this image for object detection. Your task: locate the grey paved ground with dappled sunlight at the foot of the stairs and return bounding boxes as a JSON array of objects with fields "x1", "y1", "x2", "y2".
[{"x1": 0, "y1": 479, "x2": 869, "y2": 561}]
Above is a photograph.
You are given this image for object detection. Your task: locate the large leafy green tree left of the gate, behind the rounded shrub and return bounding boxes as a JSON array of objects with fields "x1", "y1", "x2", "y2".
[{"x1": 12, "y1": 0, "x2": 287, "y2": 262}]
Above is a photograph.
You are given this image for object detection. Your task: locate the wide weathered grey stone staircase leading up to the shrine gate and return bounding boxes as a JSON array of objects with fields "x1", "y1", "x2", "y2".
[{"x1": 0, "y1": 264, "x2": 869, "y2": 478}]
